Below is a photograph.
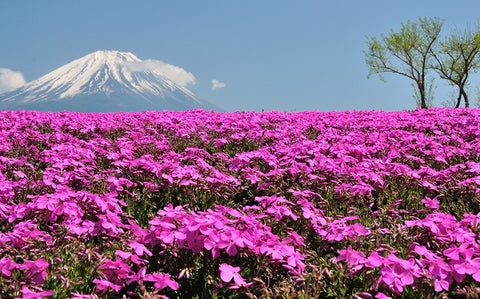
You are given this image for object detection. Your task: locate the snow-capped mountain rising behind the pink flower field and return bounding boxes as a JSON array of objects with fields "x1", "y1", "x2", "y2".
[{"x1": 0, "y1": 51, "x2": 218, "y2": 112}]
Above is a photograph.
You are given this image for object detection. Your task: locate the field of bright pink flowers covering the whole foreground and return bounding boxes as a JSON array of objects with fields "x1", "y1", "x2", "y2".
[{"x1": 0, "y1": 108, "x2": 480, "y2": 299}]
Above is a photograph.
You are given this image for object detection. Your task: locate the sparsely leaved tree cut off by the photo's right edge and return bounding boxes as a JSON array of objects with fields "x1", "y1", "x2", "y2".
[{"x1": 430, "y1": 29, "x2": 480, "y2": 108}]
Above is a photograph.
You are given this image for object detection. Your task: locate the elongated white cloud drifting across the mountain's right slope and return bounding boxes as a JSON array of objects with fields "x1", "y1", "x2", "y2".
[{"x1": 125, "y1": 59, "x2": 197, "y2": 87}]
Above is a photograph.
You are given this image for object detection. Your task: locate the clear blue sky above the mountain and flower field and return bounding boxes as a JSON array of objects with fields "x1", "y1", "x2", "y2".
[{"x1": 0, "y1": 0, "x2": 480, "y2": 111}]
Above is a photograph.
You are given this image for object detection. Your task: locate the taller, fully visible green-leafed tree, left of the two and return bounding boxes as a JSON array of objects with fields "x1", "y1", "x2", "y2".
[{"x1": 364, "y1": 18, "x2": 443, "y2": 108}]
